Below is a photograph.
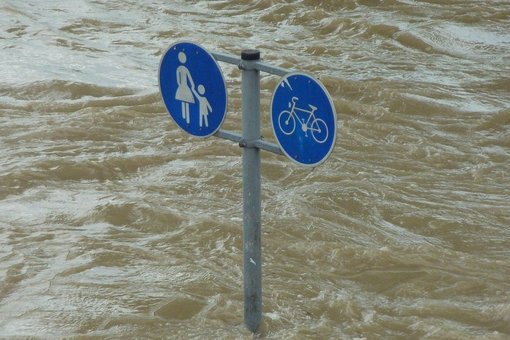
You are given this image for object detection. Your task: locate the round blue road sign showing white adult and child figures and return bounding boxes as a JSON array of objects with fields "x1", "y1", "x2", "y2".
[{"x1": 159, "y1": 42, "x2": 227, "y2": 137}]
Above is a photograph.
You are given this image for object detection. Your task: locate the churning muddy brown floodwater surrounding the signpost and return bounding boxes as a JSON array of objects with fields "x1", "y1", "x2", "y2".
[{"x1": 0, "y1": 0, "x2": 510, "y2": 339}]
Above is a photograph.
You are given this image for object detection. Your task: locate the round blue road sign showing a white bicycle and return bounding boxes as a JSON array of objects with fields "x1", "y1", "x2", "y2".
[{"x1": 271, "y1": 72, "x2": 336, "y2": 166}]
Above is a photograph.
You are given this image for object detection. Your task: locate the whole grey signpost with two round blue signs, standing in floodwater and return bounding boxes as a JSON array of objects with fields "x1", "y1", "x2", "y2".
[{"x1": 159, "y1": 42, "x2": 336, "y2": 332}]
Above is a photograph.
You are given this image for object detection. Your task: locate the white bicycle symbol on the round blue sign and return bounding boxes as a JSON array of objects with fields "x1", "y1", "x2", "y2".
[{"x1": 278, "y1": 97, "x2": 329, "y2": 144}]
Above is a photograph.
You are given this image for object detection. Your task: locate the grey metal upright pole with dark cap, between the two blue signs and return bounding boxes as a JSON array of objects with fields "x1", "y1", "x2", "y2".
[{"x1": 239, "y1": 50, "x2": 262, "y2": 332}]
